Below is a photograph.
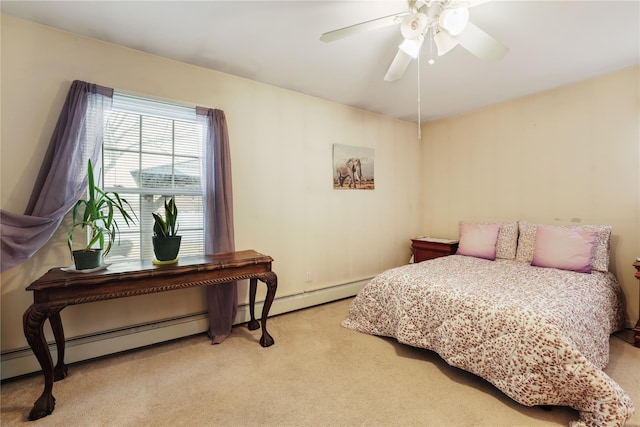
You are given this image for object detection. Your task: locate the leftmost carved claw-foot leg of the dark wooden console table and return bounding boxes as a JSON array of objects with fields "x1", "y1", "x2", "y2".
[{"x1": 22, "y1": 304, "x2": 64, "y2": 420}]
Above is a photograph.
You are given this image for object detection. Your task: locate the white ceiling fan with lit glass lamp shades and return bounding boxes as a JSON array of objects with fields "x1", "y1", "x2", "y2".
[{"x1": 320, "y1": 0, "x2": 509, "y2": 82}]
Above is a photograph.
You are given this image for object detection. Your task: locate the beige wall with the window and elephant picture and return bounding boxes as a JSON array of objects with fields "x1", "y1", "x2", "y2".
[{"x1": 0, "y1": 16, "x2": 422, "y2": 362}]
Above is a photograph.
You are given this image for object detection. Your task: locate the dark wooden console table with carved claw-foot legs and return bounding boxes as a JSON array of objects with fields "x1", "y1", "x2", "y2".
[{"x1": 23, "y1": 250, "x2": 278, "y2": 420}]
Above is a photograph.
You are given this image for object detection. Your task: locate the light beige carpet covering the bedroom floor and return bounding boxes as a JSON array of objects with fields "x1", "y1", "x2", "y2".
[{"x1": 0, "y1": 299, "x2": 640, "y2": 427}]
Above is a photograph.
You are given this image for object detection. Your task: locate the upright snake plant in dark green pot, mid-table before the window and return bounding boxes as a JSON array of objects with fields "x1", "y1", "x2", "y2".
[{"x1": 152, "y1": 196, "x2": 182, "y2": 263}]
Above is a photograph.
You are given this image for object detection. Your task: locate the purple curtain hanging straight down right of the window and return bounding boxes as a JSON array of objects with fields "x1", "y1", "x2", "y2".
[{"x1": 196, "y1": 107, "x2": 238, "y2": 344}]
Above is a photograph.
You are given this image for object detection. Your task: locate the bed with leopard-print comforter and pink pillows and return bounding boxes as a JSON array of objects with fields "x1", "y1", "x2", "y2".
[{"x1": 342, "y1": 221, "x2": 634, "y2": 426}]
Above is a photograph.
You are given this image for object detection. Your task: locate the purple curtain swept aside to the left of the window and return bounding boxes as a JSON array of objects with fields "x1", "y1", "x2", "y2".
[{"x1": 0, "y1": 80, "x2": 113, "y2": 271}]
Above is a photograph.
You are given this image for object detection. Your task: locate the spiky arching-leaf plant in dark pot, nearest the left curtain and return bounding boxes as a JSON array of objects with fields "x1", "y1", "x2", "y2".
[{"x1": 67, "y1": 160, "x2": 137, "y2": 270}]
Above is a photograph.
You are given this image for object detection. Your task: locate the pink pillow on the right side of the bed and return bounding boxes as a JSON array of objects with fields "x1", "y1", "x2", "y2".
[{"x1": 531, "y1": 225, "x2": 598, "y2": 273}]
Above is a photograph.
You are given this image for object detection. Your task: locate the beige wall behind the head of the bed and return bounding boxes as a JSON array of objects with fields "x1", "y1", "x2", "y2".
[{"x1": 422, "y1": 67, "x2": 640, "y2": 324}]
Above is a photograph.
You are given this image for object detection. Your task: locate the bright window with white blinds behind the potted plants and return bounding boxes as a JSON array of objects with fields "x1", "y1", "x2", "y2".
[{"x1": 102, "y1": 92, "x2": 205, "y2": 260}]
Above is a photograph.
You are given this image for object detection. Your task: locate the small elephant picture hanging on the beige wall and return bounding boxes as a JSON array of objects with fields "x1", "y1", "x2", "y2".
[{"x1": 333, "y1": 144, "x2": 375, "y2": 190}]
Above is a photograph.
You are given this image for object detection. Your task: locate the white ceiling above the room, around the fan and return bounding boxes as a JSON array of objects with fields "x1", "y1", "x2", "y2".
[{"x1": 0, "y1": 0, "x2": 640, "y2": 122}]
